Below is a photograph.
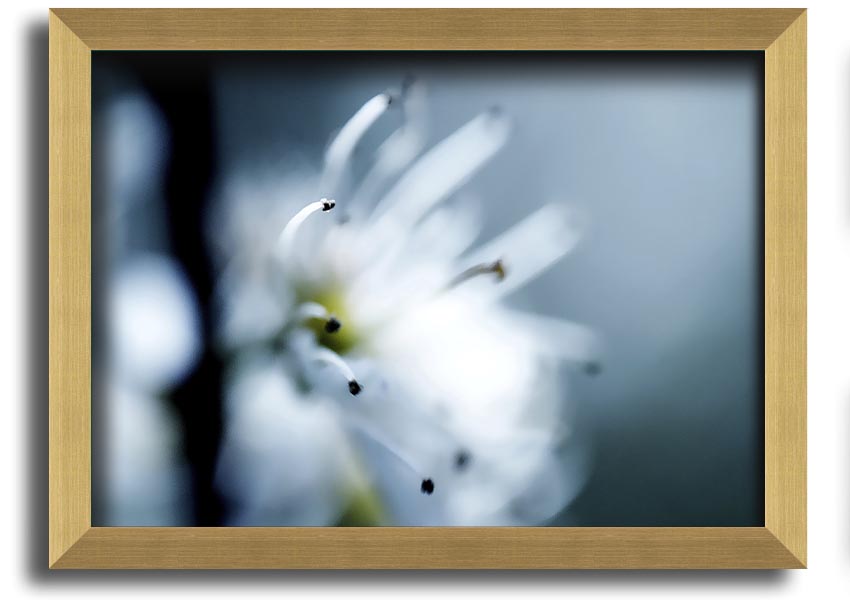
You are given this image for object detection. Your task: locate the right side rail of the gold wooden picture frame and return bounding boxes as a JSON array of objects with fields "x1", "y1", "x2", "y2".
[{"x1": 764, "y1": 13, "x2": 806, "y2": 563}]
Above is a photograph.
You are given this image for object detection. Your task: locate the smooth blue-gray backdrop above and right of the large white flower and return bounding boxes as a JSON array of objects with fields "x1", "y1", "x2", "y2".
[{"x1": 93, "y1": 53, "x2": 764, "y2": 526}]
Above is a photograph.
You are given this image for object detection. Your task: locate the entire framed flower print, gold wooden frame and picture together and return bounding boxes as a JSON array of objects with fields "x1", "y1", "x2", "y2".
[{"x1": 49, "y1": 9, "x2": 806, "y2": 569}]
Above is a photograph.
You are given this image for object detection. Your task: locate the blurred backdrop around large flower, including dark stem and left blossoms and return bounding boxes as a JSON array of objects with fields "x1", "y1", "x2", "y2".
[{"x1": 92, "y1": 52, "x2": 764, "y2": 526}]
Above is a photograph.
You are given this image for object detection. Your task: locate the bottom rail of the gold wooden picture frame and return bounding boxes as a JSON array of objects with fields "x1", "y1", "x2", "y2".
[{"x1": 56, "y1": 527, "x2": 798, "y2": 569}]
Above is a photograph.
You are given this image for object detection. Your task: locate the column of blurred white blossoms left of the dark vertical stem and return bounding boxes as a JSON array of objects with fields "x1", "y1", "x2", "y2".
[{"x1": 96, "y1": 92, "x2": 197, "y2": 526}]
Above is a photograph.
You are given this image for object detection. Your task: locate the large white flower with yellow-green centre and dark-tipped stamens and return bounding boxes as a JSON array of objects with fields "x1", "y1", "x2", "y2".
[{"x1": 211, "y1": 86, "x2": 594, "y2": 525}]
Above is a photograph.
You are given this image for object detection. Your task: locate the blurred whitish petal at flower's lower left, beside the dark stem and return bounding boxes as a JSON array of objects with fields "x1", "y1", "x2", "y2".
[{"x1": 217, "y1": 355, "x2": 348, "y2": 526}]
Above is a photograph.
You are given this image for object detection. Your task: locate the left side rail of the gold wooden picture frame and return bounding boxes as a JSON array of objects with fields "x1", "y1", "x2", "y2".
[{"x1": 48, "y1": 15, "x2": 91, "y2": 564}]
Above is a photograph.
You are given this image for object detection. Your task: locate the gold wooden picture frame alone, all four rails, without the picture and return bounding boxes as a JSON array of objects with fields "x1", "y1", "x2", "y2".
[{"x1": 48, "y1": 9, "x2": 806, "y2": 569}]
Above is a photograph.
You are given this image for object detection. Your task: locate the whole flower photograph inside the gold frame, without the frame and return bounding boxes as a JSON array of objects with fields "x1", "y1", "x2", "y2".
[{"x1": 91, "y1": 51, "x2": 765, "y2": 527}]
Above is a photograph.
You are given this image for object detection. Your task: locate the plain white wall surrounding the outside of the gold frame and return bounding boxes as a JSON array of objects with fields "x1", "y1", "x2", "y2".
[{"x1": 0, "y1": 0, "x2": 850, "y2": 600}]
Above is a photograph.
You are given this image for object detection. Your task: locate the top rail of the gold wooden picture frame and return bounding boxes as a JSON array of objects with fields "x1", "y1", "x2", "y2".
[{"x1": 55, "y1": 9, "x2": 800, "y2": 50}]
